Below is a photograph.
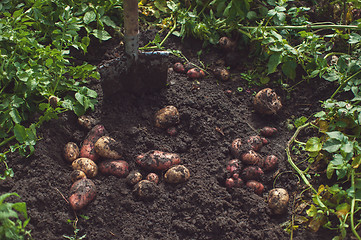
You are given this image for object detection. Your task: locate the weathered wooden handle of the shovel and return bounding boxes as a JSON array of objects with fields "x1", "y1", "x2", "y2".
[{"x1": 123, "y1": 0, "x2": 139, "y2": 60}]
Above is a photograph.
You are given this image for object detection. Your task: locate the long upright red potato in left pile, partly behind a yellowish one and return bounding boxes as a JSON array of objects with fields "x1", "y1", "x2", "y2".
[{"x1": 80, "y1": 125, "x2": 107, "y2": 161}]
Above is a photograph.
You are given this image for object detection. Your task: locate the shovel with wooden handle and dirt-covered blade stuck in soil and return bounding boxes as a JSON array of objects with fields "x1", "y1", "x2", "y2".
[{"x1": 98, "y1": 0, "x2": 168, "y2": 97}]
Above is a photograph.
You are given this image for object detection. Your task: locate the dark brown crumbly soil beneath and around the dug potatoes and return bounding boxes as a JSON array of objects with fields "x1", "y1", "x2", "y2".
[{"x1": 0, "y1": 32, "x2": 342, "y2": 240}]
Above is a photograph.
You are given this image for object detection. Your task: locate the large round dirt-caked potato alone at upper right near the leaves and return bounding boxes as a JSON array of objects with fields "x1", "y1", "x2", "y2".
[{"x1": 253, "y1": 88, "x2": 282, "y2": 115}]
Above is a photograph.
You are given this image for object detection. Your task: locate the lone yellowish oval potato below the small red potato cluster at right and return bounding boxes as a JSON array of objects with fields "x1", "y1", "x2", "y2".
[{"x1": 268, "y1": 188, "x2": 290, "y2": 214}]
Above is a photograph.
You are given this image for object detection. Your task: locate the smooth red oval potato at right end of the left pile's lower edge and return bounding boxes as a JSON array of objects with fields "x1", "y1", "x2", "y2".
[{"x1": 99, "y1": 160, "x2": 129, "y2": 177}]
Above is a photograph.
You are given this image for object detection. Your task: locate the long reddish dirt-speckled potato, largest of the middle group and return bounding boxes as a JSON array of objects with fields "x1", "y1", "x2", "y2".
[{"x1": 136, "y1": 150, "x2": 181, "y2": 171}]
